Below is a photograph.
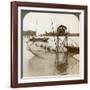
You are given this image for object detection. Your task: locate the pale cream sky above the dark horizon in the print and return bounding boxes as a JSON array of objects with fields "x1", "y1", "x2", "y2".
[{"x1": 23, "y1": 12, "x2": 80, "y2": 35}]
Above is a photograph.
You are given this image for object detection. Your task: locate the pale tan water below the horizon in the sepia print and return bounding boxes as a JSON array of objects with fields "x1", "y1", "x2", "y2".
[{"x1": 23, "y1": 36, "x2": 79, "y2": 77}]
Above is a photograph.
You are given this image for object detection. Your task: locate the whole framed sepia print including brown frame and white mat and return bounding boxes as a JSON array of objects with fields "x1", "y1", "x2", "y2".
[{"x1": 11, "y1": 1, "x2": 87, "y2": 88}]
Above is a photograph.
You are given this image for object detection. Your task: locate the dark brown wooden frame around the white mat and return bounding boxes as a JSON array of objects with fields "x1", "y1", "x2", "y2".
[{"x1": 11, "y1": 1, "x2": 88, "y2": 88}]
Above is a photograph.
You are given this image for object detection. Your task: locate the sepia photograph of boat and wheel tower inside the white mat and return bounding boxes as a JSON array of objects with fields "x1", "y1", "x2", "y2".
[{"x1": 21, "y1": 10, "x2": 80, "y2": 77}]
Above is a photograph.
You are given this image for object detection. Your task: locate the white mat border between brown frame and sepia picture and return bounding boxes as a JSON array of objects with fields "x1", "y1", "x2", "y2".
[{"x1": 18, "y1": 7, "x2": 84, "y2": 83}]
